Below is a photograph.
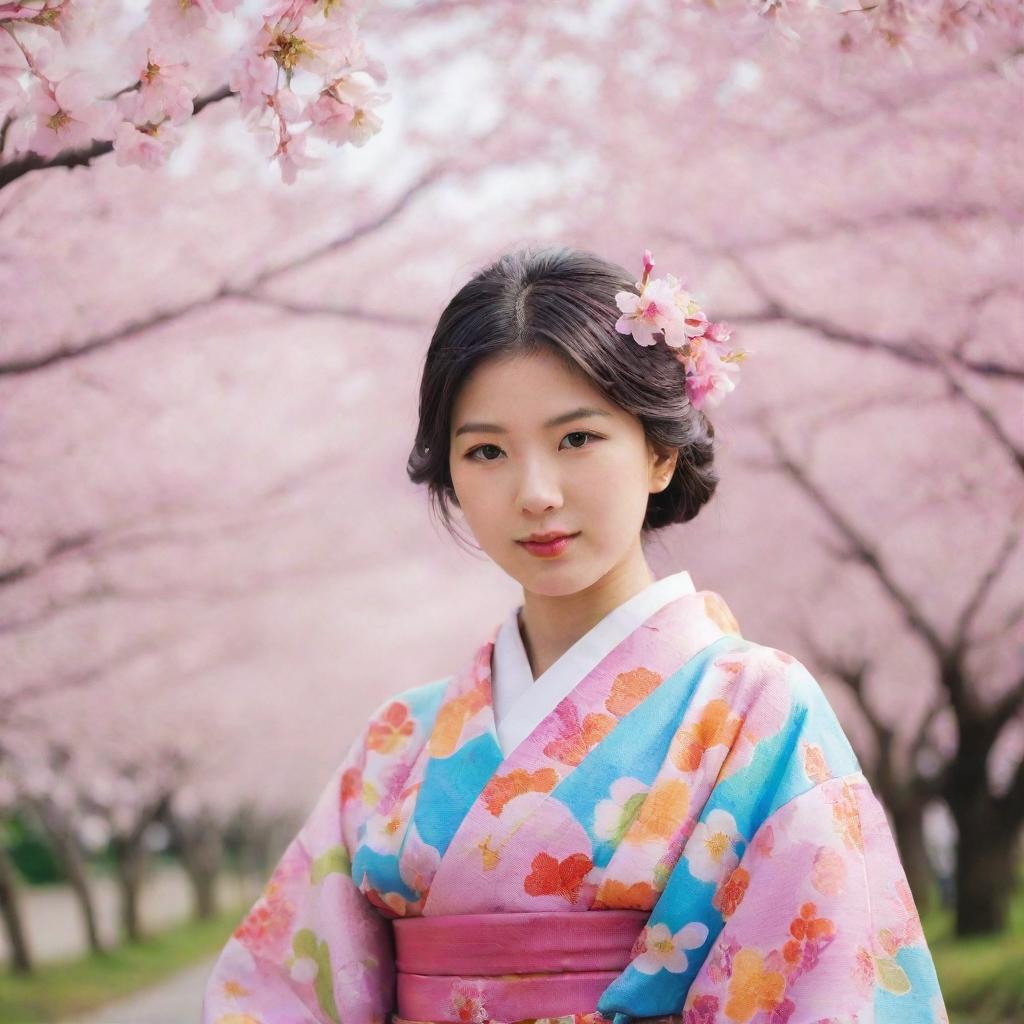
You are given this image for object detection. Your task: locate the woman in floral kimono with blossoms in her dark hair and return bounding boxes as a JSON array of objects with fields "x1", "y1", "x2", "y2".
[{"x1": 204, "y1": 243, "x2": 946, "y2": 1024}]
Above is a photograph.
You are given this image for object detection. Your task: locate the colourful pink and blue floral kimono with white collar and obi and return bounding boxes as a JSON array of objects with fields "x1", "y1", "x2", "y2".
[{"x1": 203, "y1": 572, "x2": 947, "y2": 1024}]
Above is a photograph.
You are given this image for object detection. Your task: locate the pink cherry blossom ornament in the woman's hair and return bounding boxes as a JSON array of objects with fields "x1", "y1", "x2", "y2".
[{"x1": 615, "y1": 249, "x2": 748, "y2": 409}]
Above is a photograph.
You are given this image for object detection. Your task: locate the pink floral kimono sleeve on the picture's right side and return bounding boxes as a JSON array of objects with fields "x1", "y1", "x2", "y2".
[{"x1": 683, "y1": 772, "x2": 947, "y2": 1024}]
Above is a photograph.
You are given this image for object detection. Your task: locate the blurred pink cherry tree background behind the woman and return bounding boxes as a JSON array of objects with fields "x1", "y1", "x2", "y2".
[{"x1": 0, "y1": 0, "x2": 1024, "y2": 1024}]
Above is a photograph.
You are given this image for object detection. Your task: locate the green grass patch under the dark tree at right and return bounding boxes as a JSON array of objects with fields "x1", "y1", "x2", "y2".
[{"x1": 923, "y1": 885, "x2": 1024, "y2": 1024}]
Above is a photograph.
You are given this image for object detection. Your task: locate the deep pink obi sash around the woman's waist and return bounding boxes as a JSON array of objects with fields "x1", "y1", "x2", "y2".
[{"x1": 392, "y1": 910, "x2": 648, "y2": 1024}]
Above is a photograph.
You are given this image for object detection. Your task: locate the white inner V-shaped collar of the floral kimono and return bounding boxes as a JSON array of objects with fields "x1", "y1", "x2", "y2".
[{"x1": 490, "y1": 570, "x2": 695, "y2": 757}]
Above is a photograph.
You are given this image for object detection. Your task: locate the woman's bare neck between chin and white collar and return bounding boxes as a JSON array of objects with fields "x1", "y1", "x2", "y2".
[{"x1": 519, "y1": 539, "x2": 656, "y2": 679}]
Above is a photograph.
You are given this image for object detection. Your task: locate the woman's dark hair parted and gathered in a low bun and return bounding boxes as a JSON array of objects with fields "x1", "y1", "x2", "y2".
[{"x1": 406, "y1": 247, "x2": 718, "y2": 548}]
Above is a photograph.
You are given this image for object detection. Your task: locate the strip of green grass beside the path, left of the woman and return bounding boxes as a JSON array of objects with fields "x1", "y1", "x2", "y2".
[{"x1": 0, "y1": 904, "x2": 249, "y2": 1024}]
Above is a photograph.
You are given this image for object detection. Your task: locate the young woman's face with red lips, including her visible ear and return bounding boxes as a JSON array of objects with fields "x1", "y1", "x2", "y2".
[{"x1": 450, "y1": 349, "x2": 675, "y2": 596}]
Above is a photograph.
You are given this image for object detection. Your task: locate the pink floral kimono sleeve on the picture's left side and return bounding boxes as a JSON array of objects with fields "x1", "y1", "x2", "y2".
[{"x1": 203, "y1": 742, "x2": 394, "y2": 1024}]
